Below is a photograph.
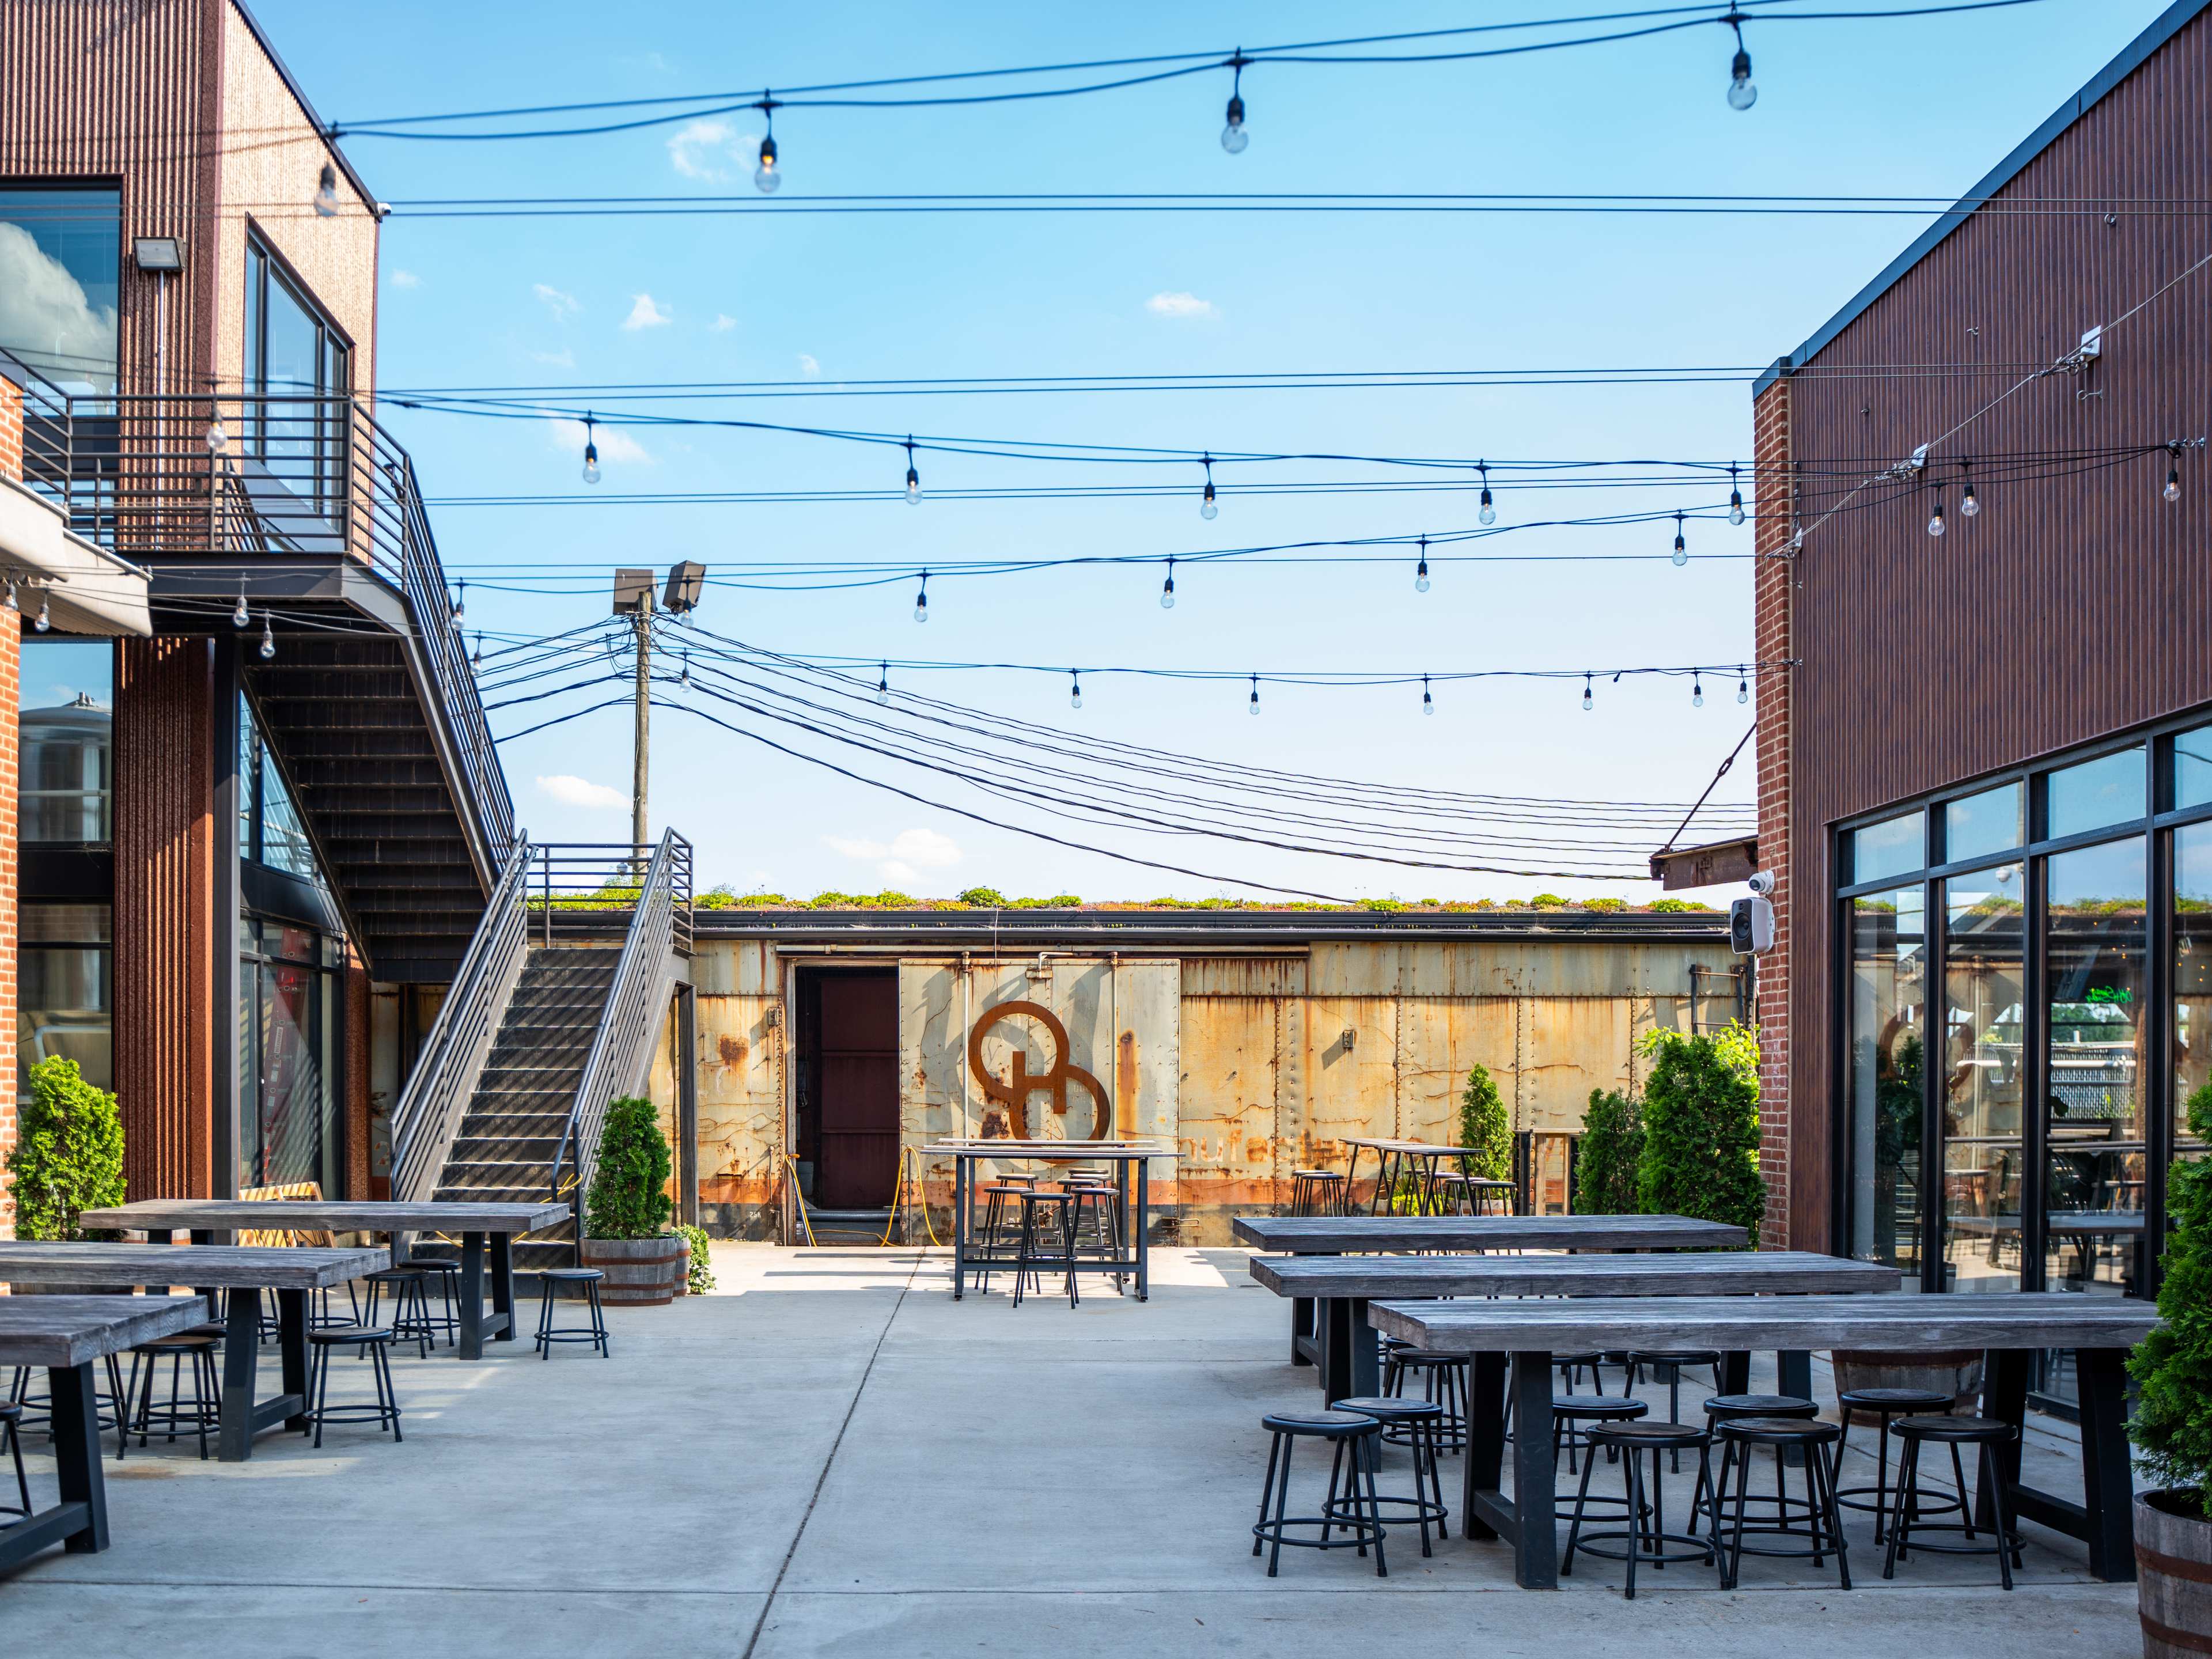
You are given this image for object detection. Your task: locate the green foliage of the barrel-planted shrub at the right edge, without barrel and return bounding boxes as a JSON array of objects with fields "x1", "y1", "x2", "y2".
[{"x1": 2128, "y1": 1084, "x2": 2212, "y2": 1520}]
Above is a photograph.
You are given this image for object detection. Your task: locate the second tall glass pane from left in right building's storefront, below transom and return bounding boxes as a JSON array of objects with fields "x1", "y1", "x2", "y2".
[{"x1": 1940, "y1": 865, "x2": 2026, "y2": 1290}]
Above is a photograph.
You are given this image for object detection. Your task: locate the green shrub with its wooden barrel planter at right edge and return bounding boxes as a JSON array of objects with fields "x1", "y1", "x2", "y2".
[{"x1": 2128, "y1": 1084, "x2": 2212, "y2": 1659}]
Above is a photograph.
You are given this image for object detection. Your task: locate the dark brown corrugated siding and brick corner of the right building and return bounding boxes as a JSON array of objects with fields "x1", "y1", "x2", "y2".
[{"x1": 1790, "y1": 18, "x2": 2212, "y2": 1248}]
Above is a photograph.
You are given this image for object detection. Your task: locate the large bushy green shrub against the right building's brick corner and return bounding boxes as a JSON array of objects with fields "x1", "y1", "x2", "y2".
[{"x1": 1637, "y1": 1024, "x2": 1767, "y2": 1238}]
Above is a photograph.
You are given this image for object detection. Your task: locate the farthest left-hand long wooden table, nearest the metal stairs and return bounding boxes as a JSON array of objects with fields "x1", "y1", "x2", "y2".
[{"x1": 79, "y1": 1199, "x2": 573, "y2": 1361}]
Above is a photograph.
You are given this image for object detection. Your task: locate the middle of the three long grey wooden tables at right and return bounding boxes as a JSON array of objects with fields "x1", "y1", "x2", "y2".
[{"x1": 1250, "y1": 1250, "x2": 1900, "y2": 1400}]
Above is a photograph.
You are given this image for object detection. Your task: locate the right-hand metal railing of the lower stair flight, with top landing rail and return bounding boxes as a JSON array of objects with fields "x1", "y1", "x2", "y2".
[{"x1": 542, "y1": 830, "x2": 692, "y2": 1238}]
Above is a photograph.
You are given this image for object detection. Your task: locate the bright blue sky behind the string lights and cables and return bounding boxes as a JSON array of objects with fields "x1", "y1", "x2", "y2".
[{"x1": 256, "y1": 0, "x2": 2161, "y2": 898}]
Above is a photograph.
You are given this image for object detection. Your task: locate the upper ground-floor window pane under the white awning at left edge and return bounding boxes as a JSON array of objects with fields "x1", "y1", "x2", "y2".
[{"x1": 16, "y1": 639, "x2": 115, "y2": 845}]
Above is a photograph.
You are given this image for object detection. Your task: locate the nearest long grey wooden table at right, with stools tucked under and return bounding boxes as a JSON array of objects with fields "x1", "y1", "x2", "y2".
[{"x1": 1367, "y1": 1290, "x2": 2159, "y2": 1590}]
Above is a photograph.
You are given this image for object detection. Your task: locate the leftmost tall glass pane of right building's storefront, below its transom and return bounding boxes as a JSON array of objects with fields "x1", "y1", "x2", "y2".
[{"x1": 1851, "y1": 887, "x2": 1927, "y2": 1283}]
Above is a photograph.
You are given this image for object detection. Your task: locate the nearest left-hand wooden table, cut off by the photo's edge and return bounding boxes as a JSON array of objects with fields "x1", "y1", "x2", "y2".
[{"x1": 0, "y1": 1296, "x2": 208, "y2": 1573}]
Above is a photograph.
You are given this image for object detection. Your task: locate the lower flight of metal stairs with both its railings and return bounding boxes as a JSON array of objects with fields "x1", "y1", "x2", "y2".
[{"x1": 392, "y1": 830, "x2": 692, "y2": 1272}]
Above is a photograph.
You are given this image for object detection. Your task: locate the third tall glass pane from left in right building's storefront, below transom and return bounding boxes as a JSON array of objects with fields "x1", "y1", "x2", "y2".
[{"x1": 2044, "y1": 836, "x2": 2148, "y2": 1294}]
